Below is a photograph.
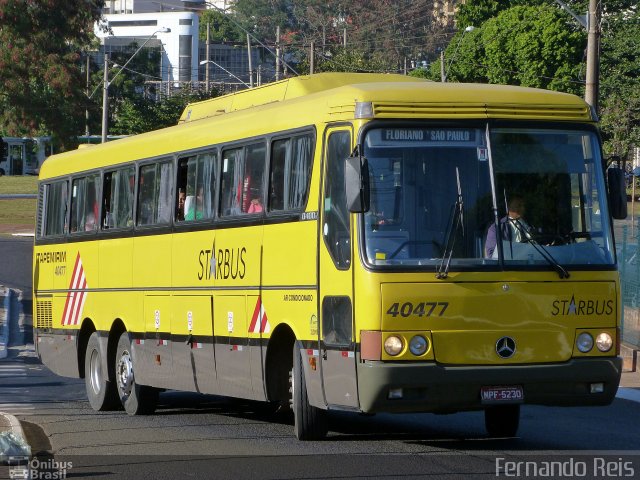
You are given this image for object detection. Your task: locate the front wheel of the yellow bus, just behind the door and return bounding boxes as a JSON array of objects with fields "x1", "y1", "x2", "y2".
[{"x1": 290, "y1": 344, "x2": 328, "y2": 440}]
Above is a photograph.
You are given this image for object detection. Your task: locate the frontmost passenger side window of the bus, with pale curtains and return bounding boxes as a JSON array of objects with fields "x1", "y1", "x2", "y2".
[{"x1": 269, "y1": 135, "x2": 313, "y2": 212}]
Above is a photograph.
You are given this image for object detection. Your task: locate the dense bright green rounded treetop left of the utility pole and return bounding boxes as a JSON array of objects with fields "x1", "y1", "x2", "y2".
[{"x1": 431, "y1": 5, "x2": 586, "y2": 94}]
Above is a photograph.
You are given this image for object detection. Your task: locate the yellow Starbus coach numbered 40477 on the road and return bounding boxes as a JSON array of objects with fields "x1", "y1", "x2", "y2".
[{"x1": 33, "y1": 73, "x2": 626, "y2": 439}]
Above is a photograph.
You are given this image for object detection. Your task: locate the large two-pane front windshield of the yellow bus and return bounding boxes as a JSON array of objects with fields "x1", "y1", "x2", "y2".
[{"x1": 363, "y1": 124, "x2": 614, "y2": 270}]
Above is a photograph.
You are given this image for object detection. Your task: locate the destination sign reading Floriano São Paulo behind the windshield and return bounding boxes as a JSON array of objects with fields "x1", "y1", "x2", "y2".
[{"x1": 367, "y1": 128, "x2": 482, "y2": 146}]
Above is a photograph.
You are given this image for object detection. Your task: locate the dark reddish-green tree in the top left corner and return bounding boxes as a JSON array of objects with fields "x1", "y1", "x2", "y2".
[{"x1": 0, "y1": 0, "x2": 104, "y2": 145}]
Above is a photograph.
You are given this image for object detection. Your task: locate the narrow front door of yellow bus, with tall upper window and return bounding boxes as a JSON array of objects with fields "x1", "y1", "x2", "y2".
[{"x1": 319, "y1": 126, "x2": 358, "y2": 408}]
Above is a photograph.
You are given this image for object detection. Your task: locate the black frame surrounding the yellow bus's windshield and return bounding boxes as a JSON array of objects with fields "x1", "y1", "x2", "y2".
[{"x1": 354, "y1": 119, "x2": 617, "y2": 276}]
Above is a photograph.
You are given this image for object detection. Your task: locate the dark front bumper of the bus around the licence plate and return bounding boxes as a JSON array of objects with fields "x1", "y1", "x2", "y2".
[{"x1": 358, "y1": 357, "x2": 622, "y2": 413}]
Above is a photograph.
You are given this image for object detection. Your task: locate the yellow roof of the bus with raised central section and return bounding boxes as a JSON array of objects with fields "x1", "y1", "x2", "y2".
[{"x1": 40, "y1": 73, "x2": 594, "y2": 178}]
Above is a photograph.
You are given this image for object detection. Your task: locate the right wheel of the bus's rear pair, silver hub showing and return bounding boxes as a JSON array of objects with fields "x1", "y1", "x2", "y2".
[{"x1": 115, "y1": 332, "x2": 158, "y2": 415}]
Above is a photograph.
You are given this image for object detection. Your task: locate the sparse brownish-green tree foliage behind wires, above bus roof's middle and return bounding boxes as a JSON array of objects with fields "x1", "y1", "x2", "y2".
[{"x1": 234, "y1": 0, "x2": 451, "y2": 72}]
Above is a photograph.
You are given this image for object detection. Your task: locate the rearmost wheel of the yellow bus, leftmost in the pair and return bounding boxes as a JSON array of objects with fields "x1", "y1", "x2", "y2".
[{"x1": 84, "y1": 332, "x2": 120, "y2": 412}]
